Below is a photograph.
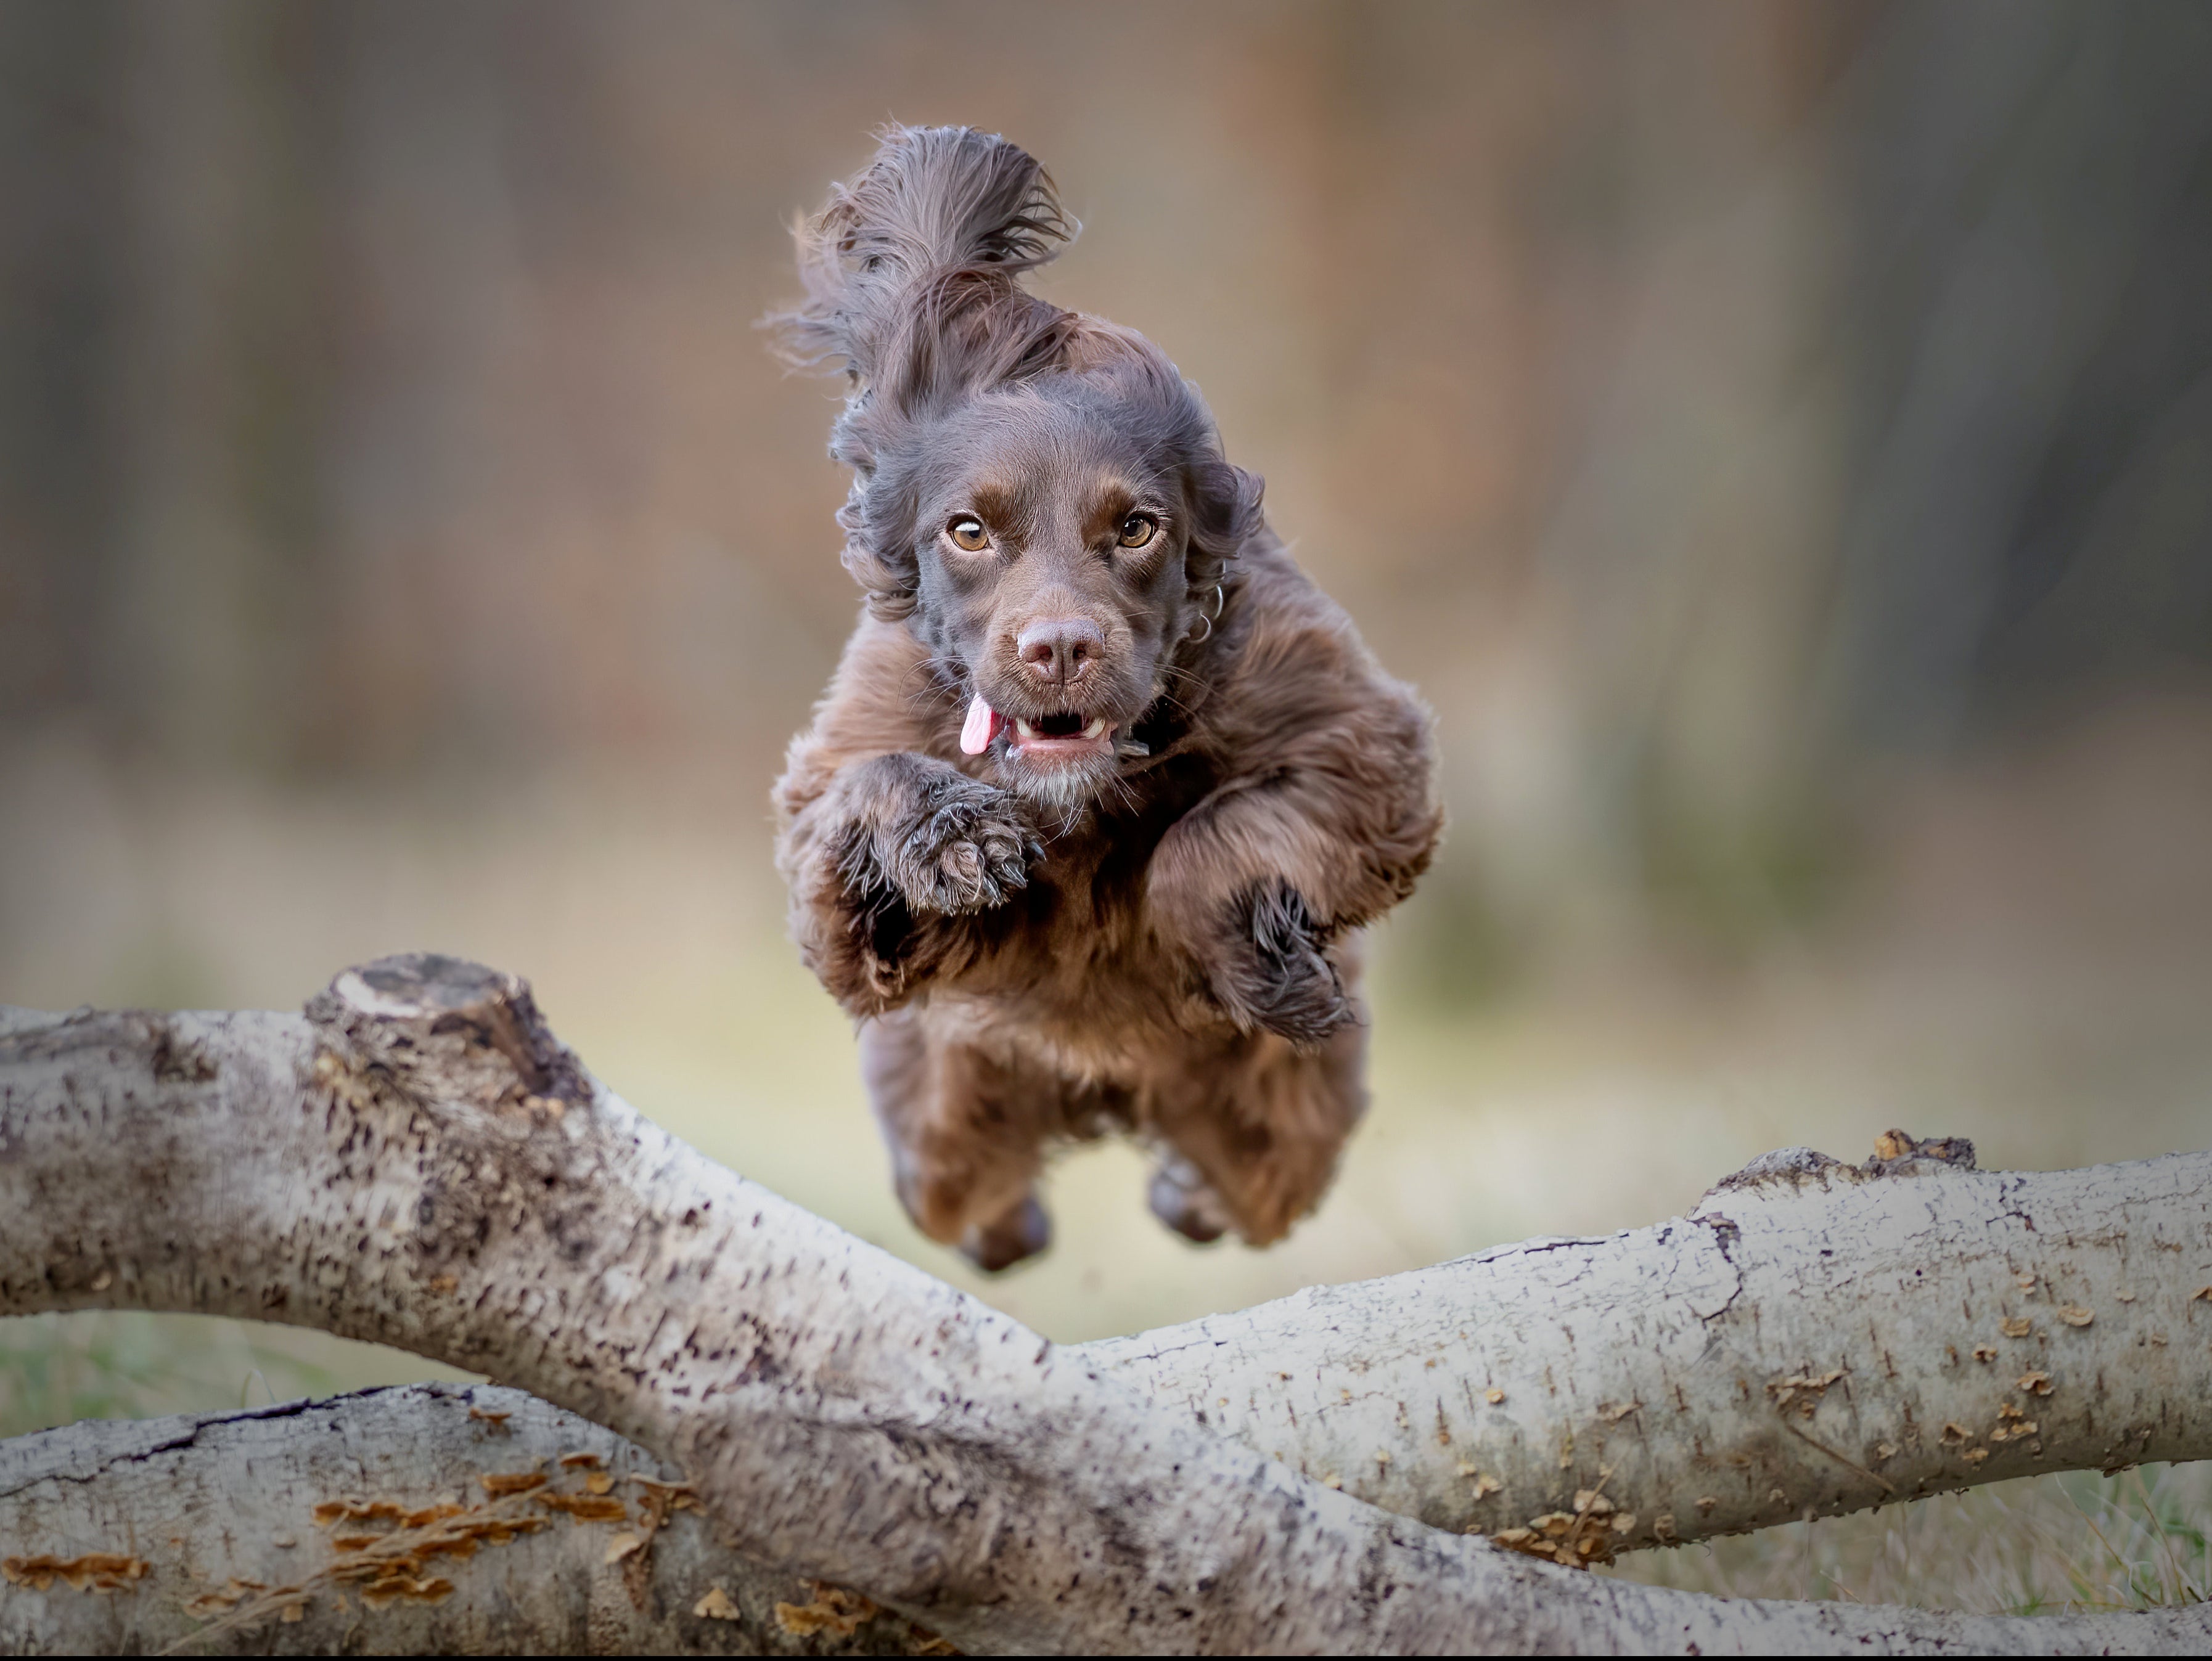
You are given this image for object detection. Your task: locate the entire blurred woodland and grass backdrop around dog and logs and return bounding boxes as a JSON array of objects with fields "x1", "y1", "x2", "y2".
[{"x1": 0, "y1": 0, "x2": 2212, "y2": 1606}]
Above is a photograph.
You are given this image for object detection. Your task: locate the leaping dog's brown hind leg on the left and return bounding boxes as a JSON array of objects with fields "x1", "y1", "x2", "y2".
[{"x1": 861, "y1": 1011, "x2": 1066, "y2": 1271}]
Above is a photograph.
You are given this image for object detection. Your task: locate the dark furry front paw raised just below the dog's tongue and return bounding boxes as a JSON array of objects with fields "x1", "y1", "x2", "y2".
[{"x1": 845, "y1": 772, "x2": 1044, "y2": 916}]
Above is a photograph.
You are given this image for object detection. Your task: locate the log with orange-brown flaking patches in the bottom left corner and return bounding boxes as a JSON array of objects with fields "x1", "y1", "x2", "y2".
[{"x1": 0, "y1": 1384, "x2": 947, "y2": 1654}]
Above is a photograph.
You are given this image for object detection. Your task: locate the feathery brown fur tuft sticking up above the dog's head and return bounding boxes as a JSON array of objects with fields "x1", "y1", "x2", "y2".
[{"x1": 768, "y1": 126, "x2": 1075, "y2": 425}]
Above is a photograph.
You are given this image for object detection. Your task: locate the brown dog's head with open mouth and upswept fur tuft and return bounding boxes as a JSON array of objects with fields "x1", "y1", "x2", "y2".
[{"x1": 776, "y1": 128, "x2": 1261, "y2": 807}]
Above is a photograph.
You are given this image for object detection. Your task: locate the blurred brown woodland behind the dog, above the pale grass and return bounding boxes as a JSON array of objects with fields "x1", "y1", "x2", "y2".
[{"x1": 0, "y1": 0, "x2": 2212, "y2": 982}]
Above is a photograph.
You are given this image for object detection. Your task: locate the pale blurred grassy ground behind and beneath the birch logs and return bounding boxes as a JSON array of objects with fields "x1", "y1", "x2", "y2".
[{"x1": 0, "y1": 708, "x2": 2212, "y2": 1610}]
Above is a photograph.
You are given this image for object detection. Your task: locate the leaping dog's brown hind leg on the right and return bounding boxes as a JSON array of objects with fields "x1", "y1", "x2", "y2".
[{"x1": 1150, "y1": 1026, "x2": 1367, "y2": 1245}]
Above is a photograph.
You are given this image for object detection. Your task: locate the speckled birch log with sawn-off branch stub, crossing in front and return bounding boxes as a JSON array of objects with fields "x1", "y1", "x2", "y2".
[{"x1": 0, "y1": 960, "x2": 2212, "y2": 1652}]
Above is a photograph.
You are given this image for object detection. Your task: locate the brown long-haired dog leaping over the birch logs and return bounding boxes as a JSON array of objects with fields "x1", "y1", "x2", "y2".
[{"x1": 776, "y1": 128, "x2": 1442, "y2": 1270}]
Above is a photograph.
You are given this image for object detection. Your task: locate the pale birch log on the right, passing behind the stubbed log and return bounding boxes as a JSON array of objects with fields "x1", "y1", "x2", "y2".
[{"x1": 1088, "y1": 1132, "x2": 2212, "y2": 1551}]
